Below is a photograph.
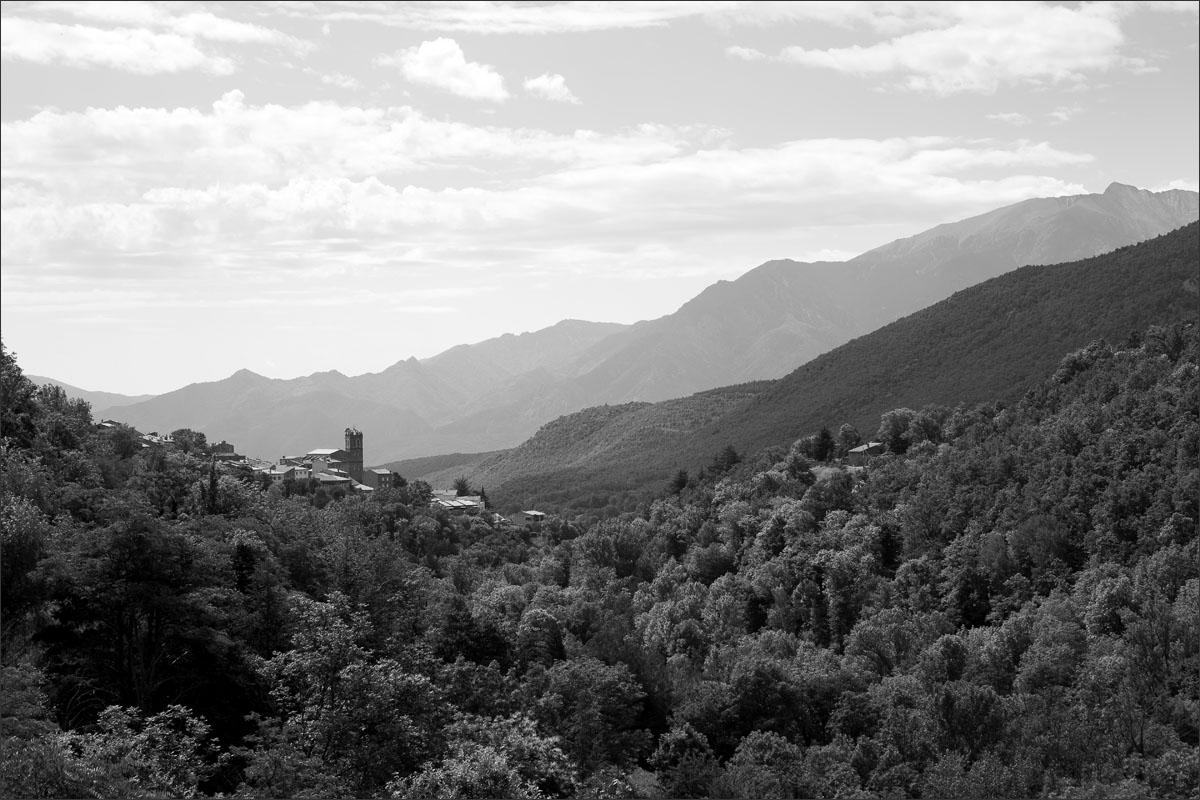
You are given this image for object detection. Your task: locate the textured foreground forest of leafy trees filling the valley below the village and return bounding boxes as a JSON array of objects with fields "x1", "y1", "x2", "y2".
[{"x1": 0, "y1": 323, "x2": 1200, "y2": 798}]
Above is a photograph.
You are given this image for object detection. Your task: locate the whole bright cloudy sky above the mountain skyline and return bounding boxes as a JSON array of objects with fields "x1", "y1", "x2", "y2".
[{"x1": 0, "y1": 1, "x2": 1200, "y2": 395}]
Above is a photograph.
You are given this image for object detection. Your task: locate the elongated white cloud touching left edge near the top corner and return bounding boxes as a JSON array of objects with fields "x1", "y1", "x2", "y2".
[{"x1": 0, "y1": 17, "x2": 234, "y2": 74}]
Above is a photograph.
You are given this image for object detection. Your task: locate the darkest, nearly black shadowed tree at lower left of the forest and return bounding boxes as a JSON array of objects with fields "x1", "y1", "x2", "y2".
[{"x1": 40, "y1": 504, "x2": 232, "y2": 723}]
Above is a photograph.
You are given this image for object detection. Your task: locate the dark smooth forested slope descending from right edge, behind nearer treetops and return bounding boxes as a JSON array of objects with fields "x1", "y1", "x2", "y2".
[{"x1": 486, "y1": 223, "x2": 1200, "y2": 512}]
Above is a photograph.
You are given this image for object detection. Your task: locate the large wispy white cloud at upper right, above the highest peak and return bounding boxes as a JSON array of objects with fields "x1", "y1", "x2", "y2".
[{"x1": 758, "y1": 2, "x2": 1146, "y2": 95}]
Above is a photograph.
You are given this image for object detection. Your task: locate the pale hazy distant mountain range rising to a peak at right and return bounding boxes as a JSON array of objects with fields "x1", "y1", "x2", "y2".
[{"x1": 79, "y1": 184, "x2": 1200, "y2": 463}]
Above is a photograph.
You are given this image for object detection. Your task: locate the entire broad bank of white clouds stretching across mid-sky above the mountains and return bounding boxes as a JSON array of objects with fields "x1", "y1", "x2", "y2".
[{"x1": 0, "y1": 91, "x2": 1091, "y2": 279}]
